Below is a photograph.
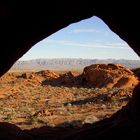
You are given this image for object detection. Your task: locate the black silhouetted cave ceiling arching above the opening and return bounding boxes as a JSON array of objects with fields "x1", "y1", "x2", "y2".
[{"x1": 0, "y1": 0, "x2": 140, "y2": 75}]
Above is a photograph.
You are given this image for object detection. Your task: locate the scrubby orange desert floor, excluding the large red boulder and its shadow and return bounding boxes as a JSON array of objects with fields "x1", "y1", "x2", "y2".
[{"x1": 0, "y1": 72, "x2": 133, "y2": 129}]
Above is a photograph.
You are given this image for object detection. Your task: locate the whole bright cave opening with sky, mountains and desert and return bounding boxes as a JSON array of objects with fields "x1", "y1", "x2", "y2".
[{"x1": 0, "y1": 17, "x2": 140, "y2": 129}]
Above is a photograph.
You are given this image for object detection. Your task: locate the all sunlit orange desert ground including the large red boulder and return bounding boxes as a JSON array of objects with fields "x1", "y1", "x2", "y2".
[{"x1": 0, "y1": 64, "x2": 139, "y2": 129}]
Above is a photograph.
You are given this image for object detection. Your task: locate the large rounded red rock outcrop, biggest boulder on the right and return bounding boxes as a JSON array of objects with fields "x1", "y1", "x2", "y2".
[{"x1": 83, "y1": 64, "x2": 138, "y2": 88}]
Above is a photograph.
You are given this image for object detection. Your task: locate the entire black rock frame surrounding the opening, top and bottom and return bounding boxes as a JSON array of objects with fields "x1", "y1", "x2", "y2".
[{"x1": 0, "y1": 0, "x2": 140, "y2": 140}]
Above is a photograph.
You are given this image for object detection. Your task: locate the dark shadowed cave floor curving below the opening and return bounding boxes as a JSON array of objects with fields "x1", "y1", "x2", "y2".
[{"x1": 0, "y1": 84, "x2": 140, "y2": 140}]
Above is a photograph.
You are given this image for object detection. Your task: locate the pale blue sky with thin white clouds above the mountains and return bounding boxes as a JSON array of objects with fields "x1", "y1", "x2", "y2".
[{"x1": 20, "y1": 16, "x2": 139, "y2": 60}]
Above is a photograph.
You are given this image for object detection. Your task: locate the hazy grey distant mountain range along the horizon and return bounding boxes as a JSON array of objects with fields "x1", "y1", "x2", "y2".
[{"x1": 11, "y1": 58, "x2": 140, "y2": 70}]
